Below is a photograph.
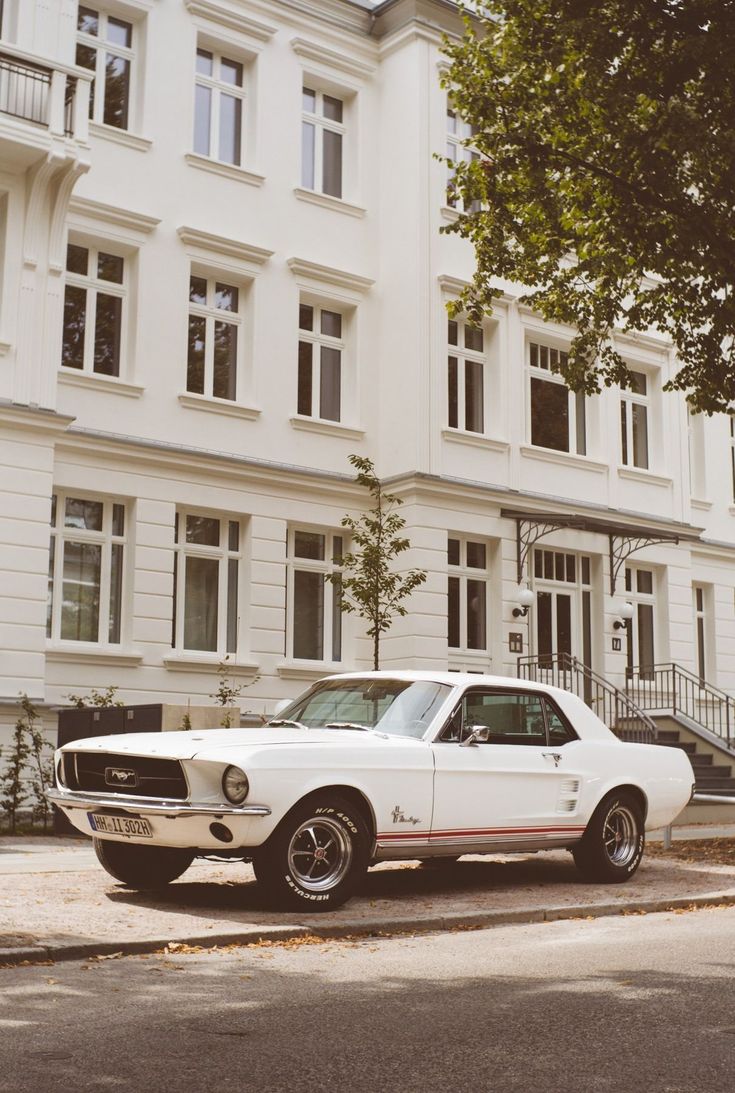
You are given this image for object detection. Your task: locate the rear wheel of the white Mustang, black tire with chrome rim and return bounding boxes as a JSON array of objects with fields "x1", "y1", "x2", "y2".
[{"x1": 572, "y1": 790, "x2": 645, "y2": 884}]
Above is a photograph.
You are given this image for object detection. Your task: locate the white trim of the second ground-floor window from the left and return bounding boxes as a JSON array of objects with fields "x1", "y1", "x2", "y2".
[{"x1": 168, "y1": 507, "x2": 246, "y2": 661}]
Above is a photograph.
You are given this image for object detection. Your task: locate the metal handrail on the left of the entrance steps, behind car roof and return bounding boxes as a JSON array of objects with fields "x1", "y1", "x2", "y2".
[{"x1": 517, "y1": 653, "x2": 656, "y2": 743}]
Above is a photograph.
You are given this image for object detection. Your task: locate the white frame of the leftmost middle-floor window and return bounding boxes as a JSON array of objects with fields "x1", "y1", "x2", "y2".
[{"x1": 59, "y1": 240, "x2": 132, "y2": 381}]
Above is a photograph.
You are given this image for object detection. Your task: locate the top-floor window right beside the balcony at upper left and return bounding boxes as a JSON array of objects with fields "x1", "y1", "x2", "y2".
[{"x1": 77, "y1": 5, "x2": 133, "y2": 129}]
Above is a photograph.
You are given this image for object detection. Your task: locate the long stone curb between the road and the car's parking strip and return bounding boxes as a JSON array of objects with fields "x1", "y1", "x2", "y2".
[{"x1": 0, "y1": 889, "x2": 735, "y2": 967}]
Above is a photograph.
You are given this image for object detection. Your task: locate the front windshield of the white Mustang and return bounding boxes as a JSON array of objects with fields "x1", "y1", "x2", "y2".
[{"x1": 273, "y1": 679, "x2": 452, "y2": 738}]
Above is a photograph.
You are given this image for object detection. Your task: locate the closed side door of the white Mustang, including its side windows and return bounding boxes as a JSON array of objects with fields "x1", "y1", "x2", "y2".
[{"x1": 431, "y1": 686, "x2": 582, "y2": 849}]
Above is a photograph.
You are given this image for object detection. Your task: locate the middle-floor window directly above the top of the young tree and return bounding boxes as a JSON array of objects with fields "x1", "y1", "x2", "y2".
[{"x1": 298, "y1": 303, "x2": 345, "y2": 421}]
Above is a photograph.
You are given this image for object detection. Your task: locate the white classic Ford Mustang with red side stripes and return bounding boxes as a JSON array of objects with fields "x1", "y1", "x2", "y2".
[{"x1": 51, "y1": 671, "x2": 695, "y2": 910}]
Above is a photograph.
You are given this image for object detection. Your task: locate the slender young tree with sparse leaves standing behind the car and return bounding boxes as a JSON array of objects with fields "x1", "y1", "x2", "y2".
[{"x1": 326, "y1": 456, "x2": 427, "y2": 671}]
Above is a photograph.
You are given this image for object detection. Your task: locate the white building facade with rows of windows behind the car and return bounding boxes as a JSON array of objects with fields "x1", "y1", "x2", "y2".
[{"x1": 0, "y1": 0, "x2": 735, "y2": 732}]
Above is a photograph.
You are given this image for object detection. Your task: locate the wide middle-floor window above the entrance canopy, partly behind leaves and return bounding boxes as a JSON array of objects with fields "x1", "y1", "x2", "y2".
[{"x1": 528, "y1": 342, "x2": 587, "y2": 456}]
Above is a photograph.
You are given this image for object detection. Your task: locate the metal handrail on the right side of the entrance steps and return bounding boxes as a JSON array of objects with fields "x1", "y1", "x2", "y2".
[{"x1": 626, "y1": 663, "x2": 735, "y2": 748}]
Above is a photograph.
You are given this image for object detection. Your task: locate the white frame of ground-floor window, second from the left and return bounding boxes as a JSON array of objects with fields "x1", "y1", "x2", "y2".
[{"x1": 171, "y1": 506, "x2": 246, "y2": 658}]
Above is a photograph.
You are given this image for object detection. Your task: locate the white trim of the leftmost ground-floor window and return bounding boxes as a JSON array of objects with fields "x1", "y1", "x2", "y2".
[{"x1": 46, "y1": 489, "x2": 127, "y2": 659}]
